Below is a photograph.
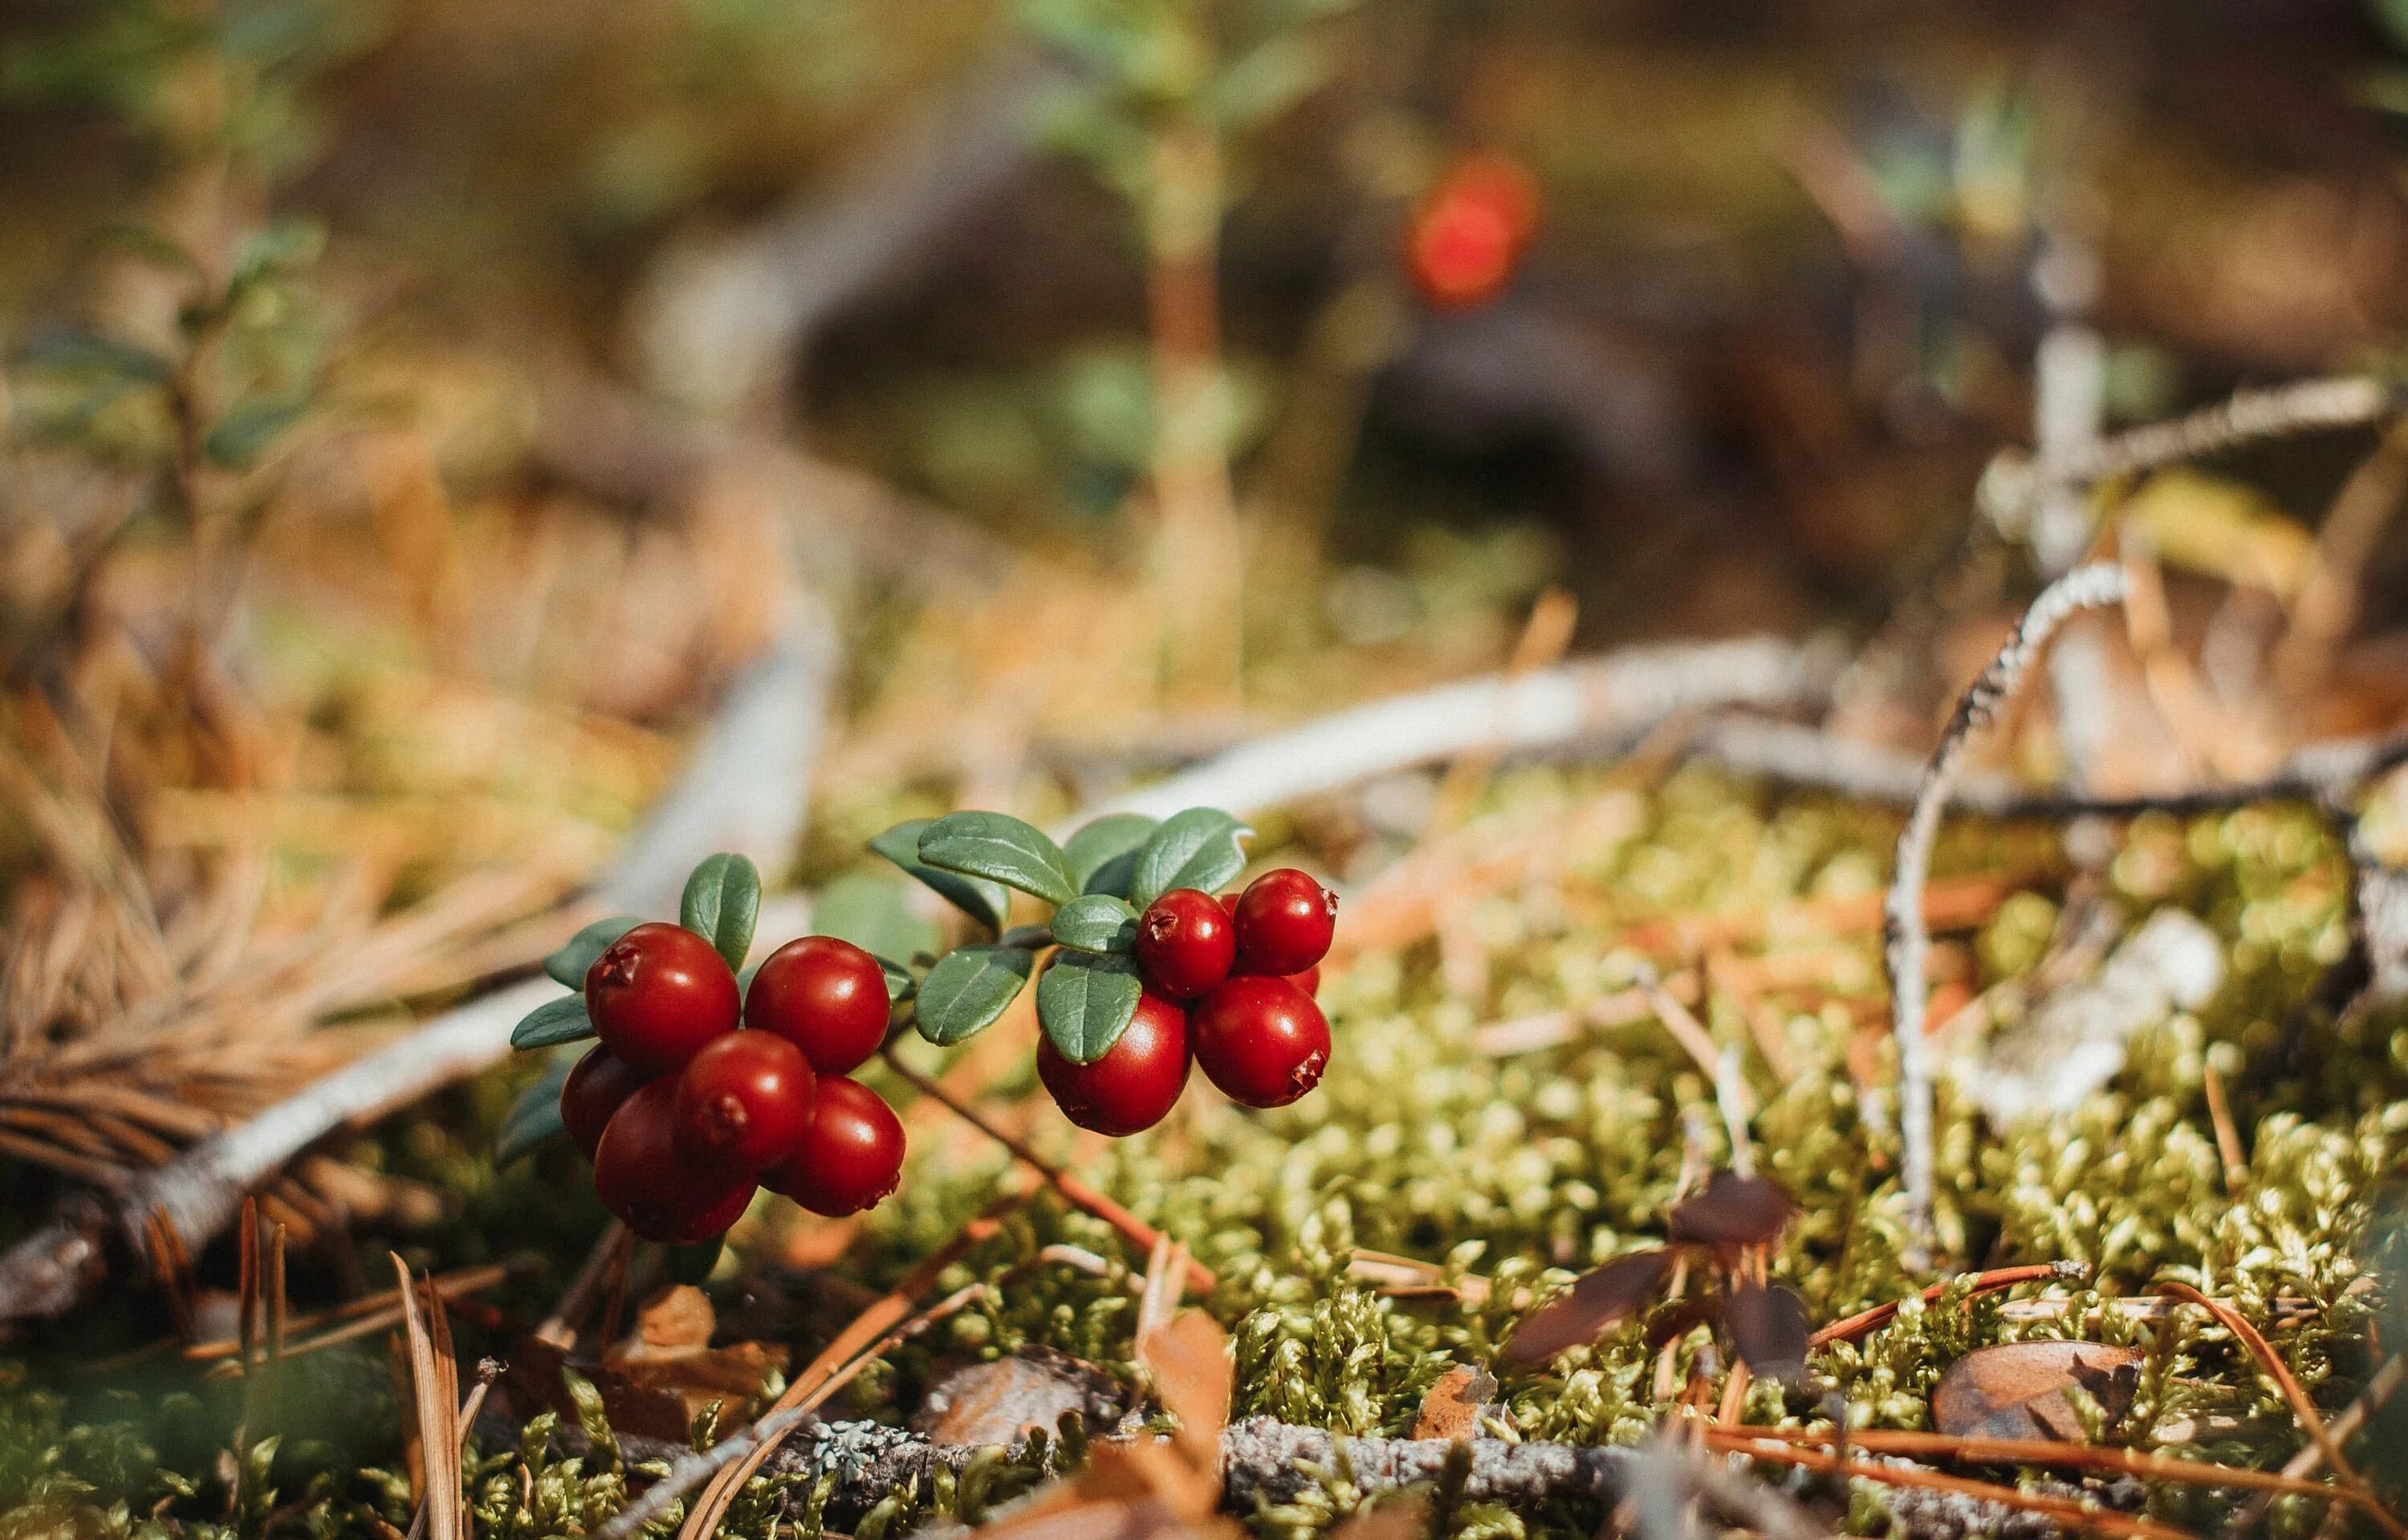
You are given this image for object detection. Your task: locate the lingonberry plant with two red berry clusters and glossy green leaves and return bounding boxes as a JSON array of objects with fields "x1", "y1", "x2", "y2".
[{"x1": 503, "y1": 808, "x2": 1336, "y2": 1244}]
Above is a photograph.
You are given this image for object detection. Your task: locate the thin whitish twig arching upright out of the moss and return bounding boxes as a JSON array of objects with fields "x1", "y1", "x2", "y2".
[{"x1": 1883, "y1": 563, "x2": 2124, "y2": 1246}]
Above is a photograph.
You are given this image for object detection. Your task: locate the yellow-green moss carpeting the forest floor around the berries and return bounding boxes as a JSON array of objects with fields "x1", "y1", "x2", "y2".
[{"x1": 0, "y1": 770, "x2": 2408, "y2": 1540}]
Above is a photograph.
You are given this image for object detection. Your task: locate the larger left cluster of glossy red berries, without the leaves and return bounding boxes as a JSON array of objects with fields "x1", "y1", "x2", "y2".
[{"x1": 561, "y1": 924, "x2": 903, "y2": 1244}]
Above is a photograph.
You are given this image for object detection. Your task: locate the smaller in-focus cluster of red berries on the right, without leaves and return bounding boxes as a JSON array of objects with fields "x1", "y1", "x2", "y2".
[{"x1": 1038, "y1": 866, "x2": 1339, "y2": 1138}]
